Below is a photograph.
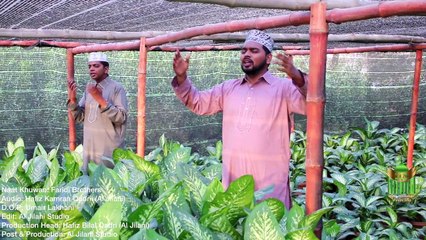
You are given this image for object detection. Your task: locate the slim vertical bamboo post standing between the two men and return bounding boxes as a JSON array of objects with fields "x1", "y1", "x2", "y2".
[{"x1": 136, "y1": 37, "x2": 148, "y2": 157}]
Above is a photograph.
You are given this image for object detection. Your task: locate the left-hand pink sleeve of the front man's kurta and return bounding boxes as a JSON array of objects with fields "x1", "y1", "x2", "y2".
[{"x1": 172, "y1": 77, "x2": 224, "y2": 115}]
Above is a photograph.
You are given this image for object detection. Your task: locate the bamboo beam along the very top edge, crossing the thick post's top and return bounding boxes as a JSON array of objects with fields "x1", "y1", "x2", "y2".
[{"x1": 167, "y1": 0, "x2": 378, "y2": 10}]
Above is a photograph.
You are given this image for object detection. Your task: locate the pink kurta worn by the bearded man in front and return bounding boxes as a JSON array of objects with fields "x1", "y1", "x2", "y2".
[{"x1": 172, "y1": 72, "x2": 308, "y2": 208}]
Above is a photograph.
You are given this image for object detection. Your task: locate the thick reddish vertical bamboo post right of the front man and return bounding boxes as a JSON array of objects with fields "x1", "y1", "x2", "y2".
[{"x1": 306, "y1": 2, "x2": 328, "y2": 237}]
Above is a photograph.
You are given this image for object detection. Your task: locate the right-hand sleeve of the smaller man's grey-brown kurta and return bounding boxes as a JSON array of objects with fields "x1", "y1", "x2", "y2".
[{"x1": 101, "y1": 86, "x2": 128, "y2": 124}]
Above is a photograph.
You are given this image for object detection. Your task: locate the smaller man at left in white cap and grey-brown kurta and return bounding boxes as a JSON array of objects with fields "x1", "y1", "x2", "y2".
[{"x1": 68, "y1": 53, "x2": 128, "y2": 173}]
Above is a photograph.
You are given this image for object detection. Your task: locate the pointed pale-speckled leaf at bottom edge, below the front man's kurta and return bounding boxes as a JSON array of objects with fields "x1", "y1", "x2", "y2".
[{"x1": 244, "y1": 202, "x2": 284, "y2": 240}]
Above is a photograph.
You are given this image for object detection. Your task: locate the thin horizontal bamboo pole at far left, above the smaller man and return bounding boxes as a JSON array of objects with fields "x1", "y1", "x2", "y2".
[{"x1": 0, "y1": 40, "x2": 85, "y2": 48}]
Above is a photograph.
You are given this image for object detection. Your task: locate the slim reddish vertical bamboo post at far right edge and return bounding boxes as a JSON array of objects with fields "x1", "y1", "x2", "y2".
[{"x1": 407, "y1": 50, "x2": 423, "y2": 169}]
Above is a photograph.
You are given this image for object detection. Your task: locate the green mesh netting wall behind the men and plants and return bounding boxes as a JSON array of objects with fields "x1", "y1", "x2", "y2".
[{"x1": 0, "y1": 47, "x2": 426, "y2": 154}]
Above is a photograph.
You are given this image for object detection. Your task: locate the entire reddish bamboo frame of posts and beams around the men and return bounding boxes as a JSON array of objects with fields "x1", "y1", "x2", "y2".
[{"x1": 0, "y1": 0, "x2": 426, "y2": 236}]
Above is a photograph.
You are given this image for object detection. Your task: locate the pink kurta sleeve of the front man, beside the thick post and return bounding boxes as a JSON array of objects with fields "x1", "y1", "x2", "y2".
[{"x1": 288, "y1": 74, "x2": 309, "y2": 115}]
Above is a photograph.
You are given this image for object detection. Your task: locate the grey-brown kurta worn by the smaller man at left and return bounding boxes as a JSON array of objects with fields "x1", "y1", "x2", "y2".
[{"x1": 68, "y1": 77, "x2": 128, "y2": 172}]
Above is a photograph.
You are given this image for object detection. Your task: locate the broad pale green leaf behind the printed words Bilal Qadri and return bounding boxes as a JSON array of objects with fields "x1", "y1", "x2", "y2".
[{"x1": 80, "y1": 201, "x2": 123, "y2": 239}]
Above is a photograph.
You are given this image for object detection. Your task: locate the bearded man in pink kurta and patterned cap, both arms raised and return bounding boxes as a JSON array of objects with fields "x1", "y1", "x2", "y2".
[{"x1": 172, "y1": 30, "x2": 307, "y2": 208}]
